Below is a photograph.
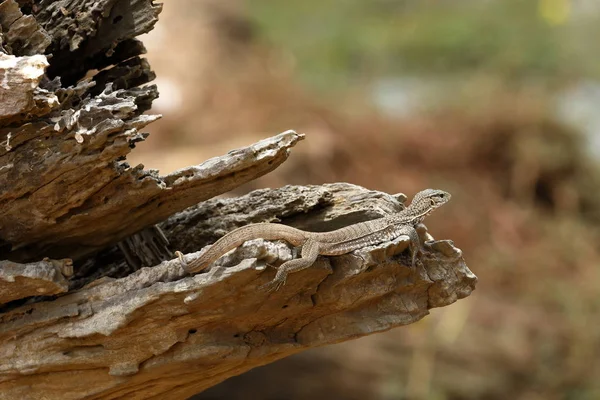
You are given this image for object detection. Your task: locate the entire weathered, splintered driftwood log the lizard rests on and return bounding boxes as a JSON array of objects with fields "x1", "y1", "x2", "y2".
[{"x1": 0, "y1": 0, "x2": 476, "y2": 399}]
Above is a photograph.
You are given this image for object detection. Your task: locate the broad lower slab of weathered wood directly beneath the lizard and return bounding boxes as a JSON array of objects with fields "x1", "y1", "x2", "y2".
[{"x1": 0, "y1": 187, "x2": 477, "y2": 399}]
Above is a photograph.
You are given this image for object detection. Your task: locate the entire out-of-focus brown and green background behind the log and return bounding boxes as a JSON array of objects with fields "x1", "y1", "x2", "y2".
[{"x1": 129, "y1": 0, "x2": 600, "y2": 400}]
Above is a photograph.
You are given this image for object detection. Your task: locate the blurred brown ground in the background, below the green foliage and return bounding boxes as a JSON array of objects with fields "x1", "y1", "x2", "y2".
[{"x1": 129, "y1": 0, "x2": 600, "y2": 400}]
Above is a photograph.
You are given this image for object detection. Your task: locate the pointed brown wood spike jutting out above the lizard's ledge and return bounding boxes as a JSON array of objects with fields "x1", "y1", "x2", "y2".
[{"x1": 0, "y1": 122, "x2": 303, "y2": 260}]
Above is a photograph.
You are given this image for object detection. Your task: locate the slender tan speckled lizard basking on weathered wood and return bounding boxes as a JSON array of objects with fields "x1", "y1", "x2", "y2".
[{"x1": 175, "y1": 189, "x2": 451, "y2": 291}]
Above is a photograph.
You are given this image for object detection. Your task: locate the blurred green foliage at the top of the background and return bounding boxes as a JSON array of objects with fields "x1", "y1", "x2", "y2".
[{"x1": 247, "y1": 0, "x2": 600, "y2": 87}]
